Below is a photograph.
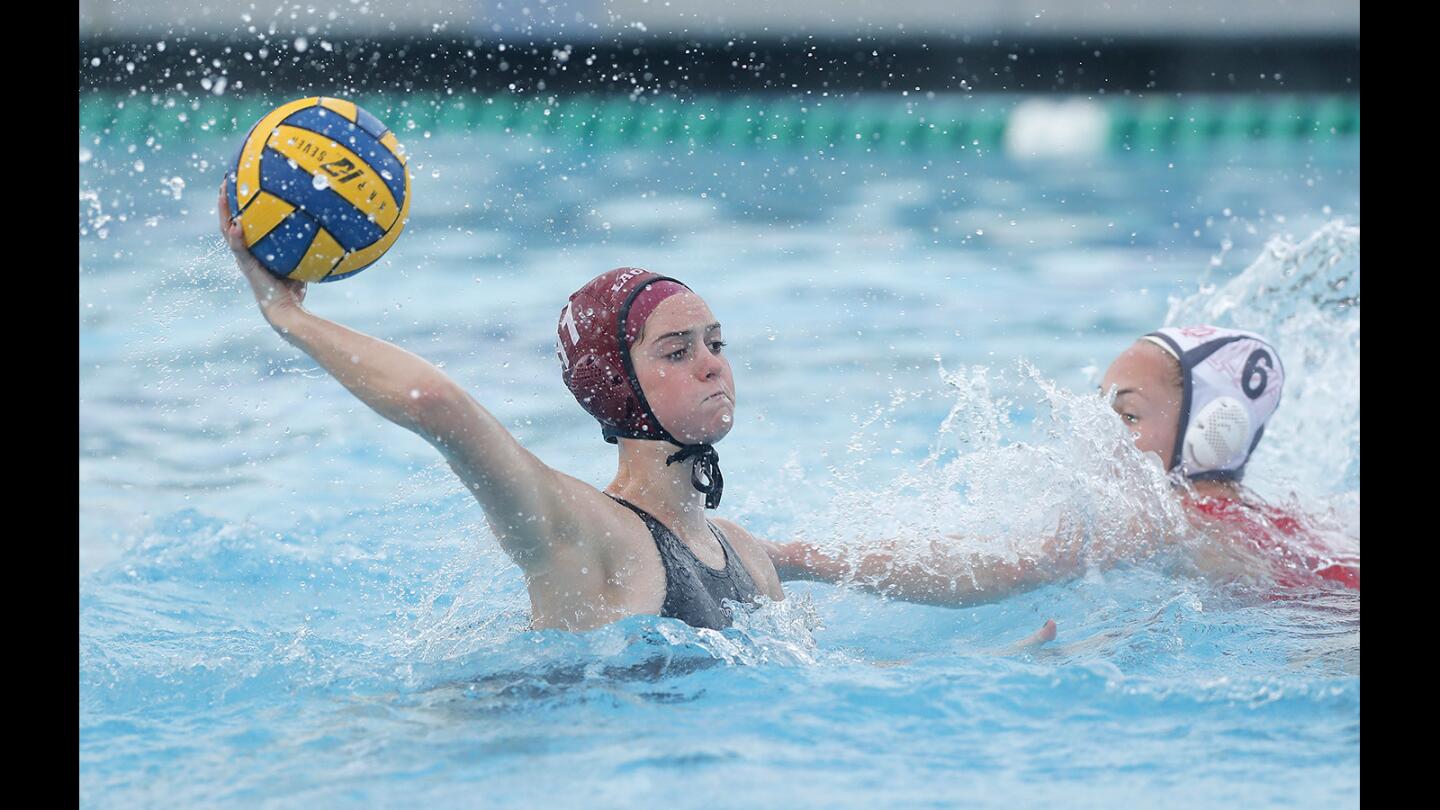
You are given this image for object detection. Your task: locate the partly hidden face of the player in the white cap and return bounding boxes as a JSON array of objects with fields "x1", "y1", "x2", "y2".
[{"x1": 1100, "y1": 340, "x2": 1184, "y2": 470}]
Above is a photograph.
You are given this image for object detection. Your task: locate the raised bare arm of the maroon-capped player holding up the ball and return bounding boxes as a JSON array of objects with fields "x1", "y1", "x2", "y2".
[{"x1": 219, "y1": 179, "x2": 562, "y2": 572}]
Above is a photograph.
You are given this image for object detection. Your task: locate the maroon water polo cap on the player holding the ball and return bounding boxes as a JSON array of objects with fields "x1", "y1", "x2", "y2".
[{"x1": 556, "y1": 267, "x2": 687, "y2": 445}]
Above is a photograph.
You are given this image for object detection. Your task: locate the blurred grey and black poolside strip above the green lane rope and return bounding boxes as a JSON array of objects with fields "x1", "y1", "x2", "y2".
[{"x1": 79, "y1": 0, "x2": 1359, "y2": 95}]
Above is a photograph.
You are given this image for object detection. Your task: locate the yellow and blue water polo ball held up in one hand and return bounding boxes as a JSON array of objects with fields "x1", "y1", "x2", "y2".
[{"x1": 226, "y1": 98, "x2": 410, "y2": 281}]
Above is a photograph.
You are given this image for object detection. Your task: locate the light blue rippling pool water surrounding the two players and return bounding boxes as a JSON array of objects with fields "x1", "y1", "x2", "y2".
[{"x1": 79, "y1": 124, "x2": 1359, "y2": 807}]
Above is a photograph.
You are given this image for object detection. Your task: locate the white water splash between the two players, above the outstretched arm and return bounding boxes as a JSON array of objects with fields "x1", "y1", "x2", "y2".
[{"x1": 798, "y1": 360, "x2": 1194, "y2": 587}]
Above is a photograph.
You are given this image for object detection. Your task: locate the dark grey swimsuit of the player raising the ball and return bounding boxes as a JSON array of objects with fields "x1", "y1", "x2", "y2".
[{"x1": 606, "y1": 493, "x2": 760, "y2": 630}]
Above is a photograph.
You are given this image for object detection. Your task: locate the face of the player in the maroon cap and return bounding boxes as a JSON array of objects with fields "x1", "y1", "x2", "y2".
[{"x1": 631, "y1": 291, "x2": 734, "y2": 444}]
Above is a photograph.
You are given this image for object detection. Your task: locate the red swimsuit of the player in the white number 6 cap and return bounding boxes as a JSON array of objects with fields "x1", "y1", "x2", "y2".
[{"x1": 1189, "y1": 497, "x2": 1359, "y2": 591}]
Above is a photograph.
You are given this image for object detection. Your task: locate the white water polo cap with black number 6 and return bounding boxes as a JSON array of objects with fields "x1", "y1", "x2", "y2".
[{"x1": 1142, "y1": 326, "x2": 1284, "y2": 480}]
